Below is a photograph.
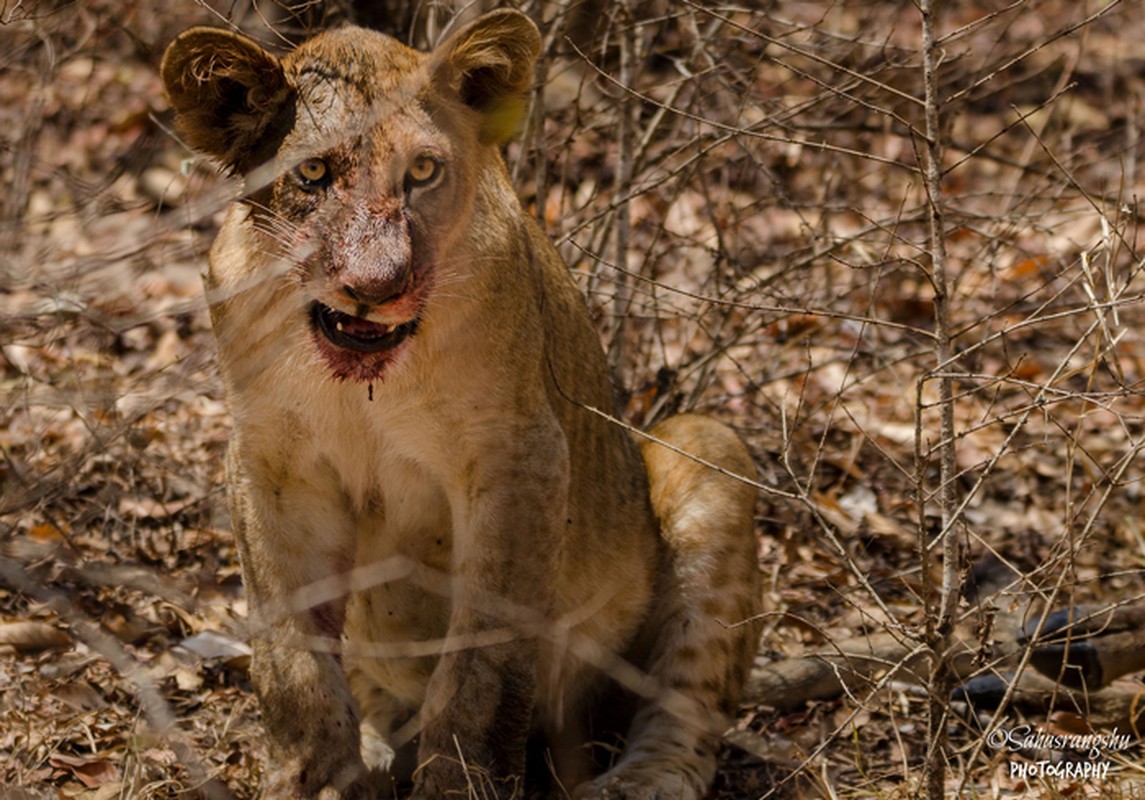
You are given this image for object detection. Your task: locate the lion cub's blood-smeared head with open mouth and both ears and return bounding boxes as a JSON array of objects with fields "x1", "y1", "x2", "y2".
[{"x1": 163, "y1": 14, "x2": 532, "y2": 382}]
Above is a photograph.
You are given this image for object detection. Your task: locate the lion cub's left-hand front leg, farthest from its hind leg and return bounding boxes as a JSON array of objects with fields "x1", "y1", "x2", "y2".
[{"x1": 228, "y1": 442, "x2": 370, "y2": 800}]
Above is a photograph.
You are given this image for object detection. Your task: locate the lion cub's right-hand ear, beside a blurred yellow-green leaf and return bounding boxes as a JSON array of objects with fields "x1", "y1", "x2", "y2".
[{"x1": 431, "y1": 8, "x2": 540, "y2": 143}]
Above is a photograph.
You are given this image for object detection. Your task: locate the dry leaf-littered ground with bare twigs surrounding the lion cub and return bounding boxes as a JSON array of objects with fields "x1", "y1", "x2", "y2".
[{"x1": 0, "y1": 0, "x2": 1145, "y2": 800}]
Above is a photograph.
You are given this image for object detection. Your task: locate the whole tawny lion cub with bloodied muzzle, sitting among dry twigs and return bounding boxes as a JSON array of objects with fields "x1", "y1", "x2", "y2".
[{"x1": 163, "y1": 10, "x2": 759, "y2": 800}]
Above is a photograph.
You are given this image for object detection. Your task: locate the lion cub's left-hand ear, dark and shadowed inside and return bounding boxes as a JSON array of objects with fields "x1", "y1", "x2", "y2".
[{"x1": 159, "y1": 27, "x2": 292, "y2": 173}]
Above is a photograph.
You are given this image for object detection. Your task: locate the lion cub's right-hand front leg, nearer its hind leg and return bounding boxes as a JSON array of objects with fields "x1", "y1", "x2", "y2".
[{"x1": 413, "y1": 422, "x2": 568, "y2": 800}]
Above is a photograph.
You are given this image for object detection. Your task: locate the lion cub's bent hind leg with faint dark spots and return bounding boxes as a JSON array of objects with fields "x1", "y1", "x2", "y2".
[{"x1": 578, "y1": 414, "x2": 760, "y2": 800}]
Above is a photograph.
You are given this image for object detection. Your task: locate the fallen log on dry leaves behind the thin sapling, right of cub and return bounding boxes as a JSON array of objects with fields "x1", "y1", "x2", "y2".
[{"x1": 745, "y1": 563, "x2": 1145, "y2": 731}]
